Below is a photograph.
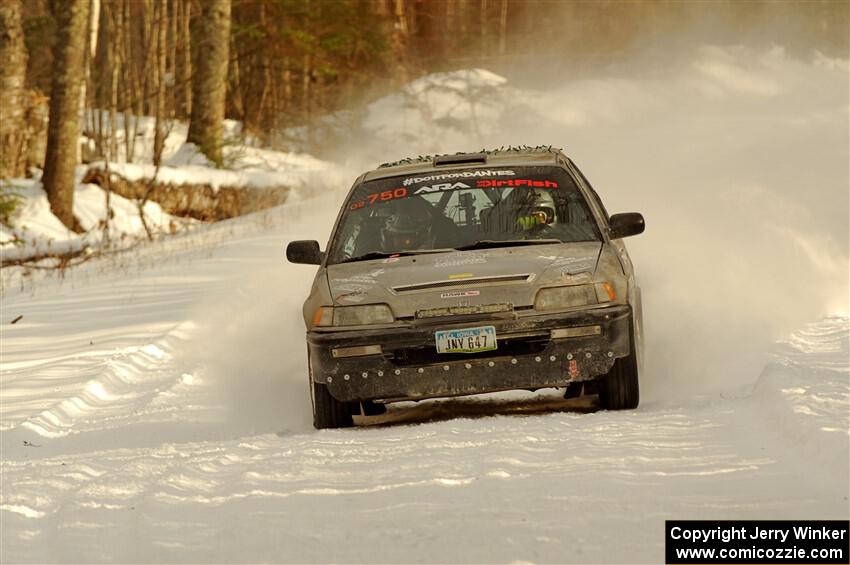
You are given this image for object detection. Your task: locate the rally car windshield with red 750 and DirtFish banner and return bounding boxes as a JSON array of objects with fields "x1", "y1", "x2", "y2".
[{"x1": 329, "y1": 167, "x2": 601, "y2": 264}]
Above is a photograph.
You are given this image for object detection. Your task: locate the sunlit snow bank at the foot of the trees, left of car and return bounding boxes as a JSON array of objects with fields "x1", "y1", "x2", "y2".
[{"x1": 0, "y1": 115, "x2": 342, "y2": 270}]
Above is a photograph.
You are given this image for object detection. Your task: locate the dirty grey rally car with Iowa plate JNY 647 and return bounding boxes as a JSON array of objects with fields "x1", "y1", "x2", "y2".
[{"x1": 286, "y1": 148, "x2": 644, "y2": 428}]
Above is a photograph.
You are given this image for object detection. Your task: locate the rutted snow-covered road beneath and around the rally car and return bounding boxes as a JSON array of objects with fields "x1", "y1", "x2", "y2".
[{"x1": 0, "y1": 196, "x2": 850, "y2": 563}]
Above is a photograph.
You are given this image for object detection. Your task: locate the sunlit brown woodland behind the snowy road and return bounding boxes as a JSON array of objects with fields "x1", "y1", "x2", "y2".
[{"x1": 0, "y1": 0, "x2": 850, "y2": 229}]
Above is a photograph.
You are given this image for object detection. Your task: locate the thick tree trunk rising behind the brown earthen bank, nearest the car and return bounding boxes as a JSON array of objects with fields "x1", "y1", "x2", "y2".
[{"x1": 187, "y1": 0, "x2": 230, "y2": 166}]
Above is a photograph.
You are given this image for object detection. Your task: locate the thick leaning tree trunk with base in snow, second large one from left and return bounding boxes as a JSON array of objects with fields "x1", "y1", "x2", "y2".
[{"x1": 42, "y1": 0, "x2": 89, "y2": 230}]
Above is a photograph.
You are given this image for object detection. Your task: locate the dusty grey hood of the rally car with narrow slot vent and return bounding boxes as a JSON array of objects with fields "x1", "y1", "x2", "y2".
[{"x1": 326, "y1": 242, "x2": 602, "y2": 318}]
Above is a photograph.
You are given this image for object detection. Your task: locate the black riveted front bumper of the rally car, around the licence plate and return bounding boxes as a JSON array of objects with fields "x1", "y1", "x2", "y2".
[{"x1": 307, "y1": 305, "x2": 632, "y2": 401}]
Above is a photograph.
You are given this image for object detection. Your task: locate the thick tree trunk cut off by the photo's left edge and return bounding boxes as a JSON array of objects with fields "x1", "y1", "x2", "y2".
[{"x1": 0, "y1": 0, "x2": 27, "y2": 178}]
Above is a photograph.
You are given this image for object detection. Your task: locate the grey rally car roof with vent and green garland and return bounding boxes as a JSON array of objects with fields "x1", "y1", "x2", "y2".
[{"x1": 358, "y1": 146, "x2": 567, "y2": 182}]
